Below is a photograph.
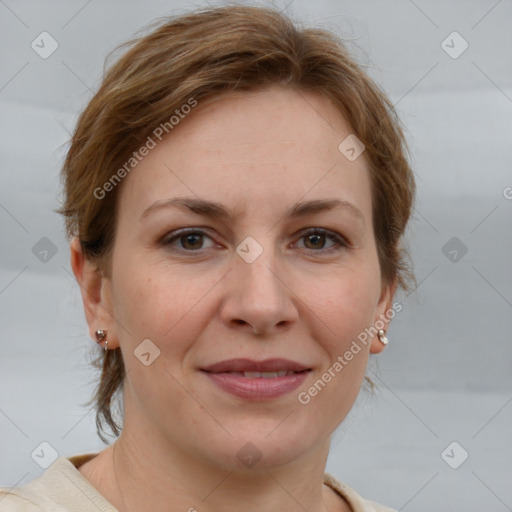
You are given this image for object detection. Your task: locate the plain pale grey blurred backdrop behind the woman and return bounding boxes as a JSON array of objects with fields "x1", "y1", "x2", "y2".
[{"x1": 0, "y1": 0, "x2": 512, "y2": 512}]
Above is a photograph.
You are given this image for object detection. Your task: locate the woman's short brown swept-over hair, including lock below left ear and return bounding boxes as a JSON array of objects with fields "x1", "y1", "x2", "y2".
[{"x1": 58, "y1": 5, "x2": 415, "y2": 442}]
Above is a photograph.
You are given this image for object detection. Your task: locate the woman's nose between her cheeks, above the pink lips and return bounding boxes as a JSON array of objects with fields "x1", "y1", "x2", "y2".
[{"x1": 221, "y1": 249, "x2": 299, "y2": 337}]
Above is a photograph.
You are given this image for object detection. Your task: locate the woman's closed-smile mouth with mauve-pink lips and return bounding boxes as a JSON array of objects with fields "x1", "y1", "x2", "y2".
[{"x1": 201, "y1": 359, "x2": 312, "y2": 401}]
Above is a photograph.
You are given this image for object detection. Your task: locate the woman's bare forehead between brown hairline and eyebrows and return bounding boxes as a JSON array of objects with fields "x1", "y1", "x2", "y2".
[{"x1": 116, "y1": 86, "x2": 371, "y2": 224}]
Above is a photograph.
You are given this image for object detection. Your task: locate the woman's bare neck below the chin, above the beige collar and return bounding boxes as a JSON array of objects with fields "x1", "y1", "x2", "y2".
[{"x1": 109, "y1": 425, "x2": 343, "y2": 512}]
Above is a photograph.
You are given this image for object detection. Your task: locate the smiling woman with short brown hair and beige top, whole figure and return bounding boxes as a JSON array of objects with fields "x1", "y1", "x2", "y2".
[{"x1": 1, "y1": 6, "x2": 414, "y2": 512}]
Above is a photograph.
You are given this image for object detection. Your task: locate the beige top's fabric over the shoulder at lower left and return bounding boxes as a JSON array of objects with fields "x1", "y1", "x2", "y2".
[{"x1": 0, "y1": 454, "x2": 115, "y2": 512}]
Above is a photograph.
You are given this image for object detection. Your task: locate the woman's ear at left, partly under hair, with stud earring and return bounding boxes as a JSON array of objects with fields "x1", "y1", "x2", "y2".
[{"x1": 69, "y1": 237, "x2": 119, "y2": 349}]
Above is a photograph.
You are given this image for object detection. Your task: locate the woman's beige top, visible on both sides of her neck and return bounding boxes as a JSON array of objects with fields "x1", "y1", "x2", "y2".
[{"x1": 0, "y1": 453, "x2": 396, "y2": 512}]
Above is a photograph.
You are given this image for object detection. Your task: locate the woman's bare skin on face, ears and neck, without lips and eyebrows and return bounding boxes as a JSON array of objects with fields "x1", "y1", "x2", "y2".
[{"x1": 71, "y1": 86, "x2": 394, "y2": 512}]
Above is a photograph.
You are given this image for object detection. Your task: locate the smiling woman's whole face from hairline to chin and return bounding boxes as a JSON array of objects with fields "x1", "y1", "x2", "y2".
[{"x1": 91, "y1": 87, "x2": 391, "y2": 468}]
